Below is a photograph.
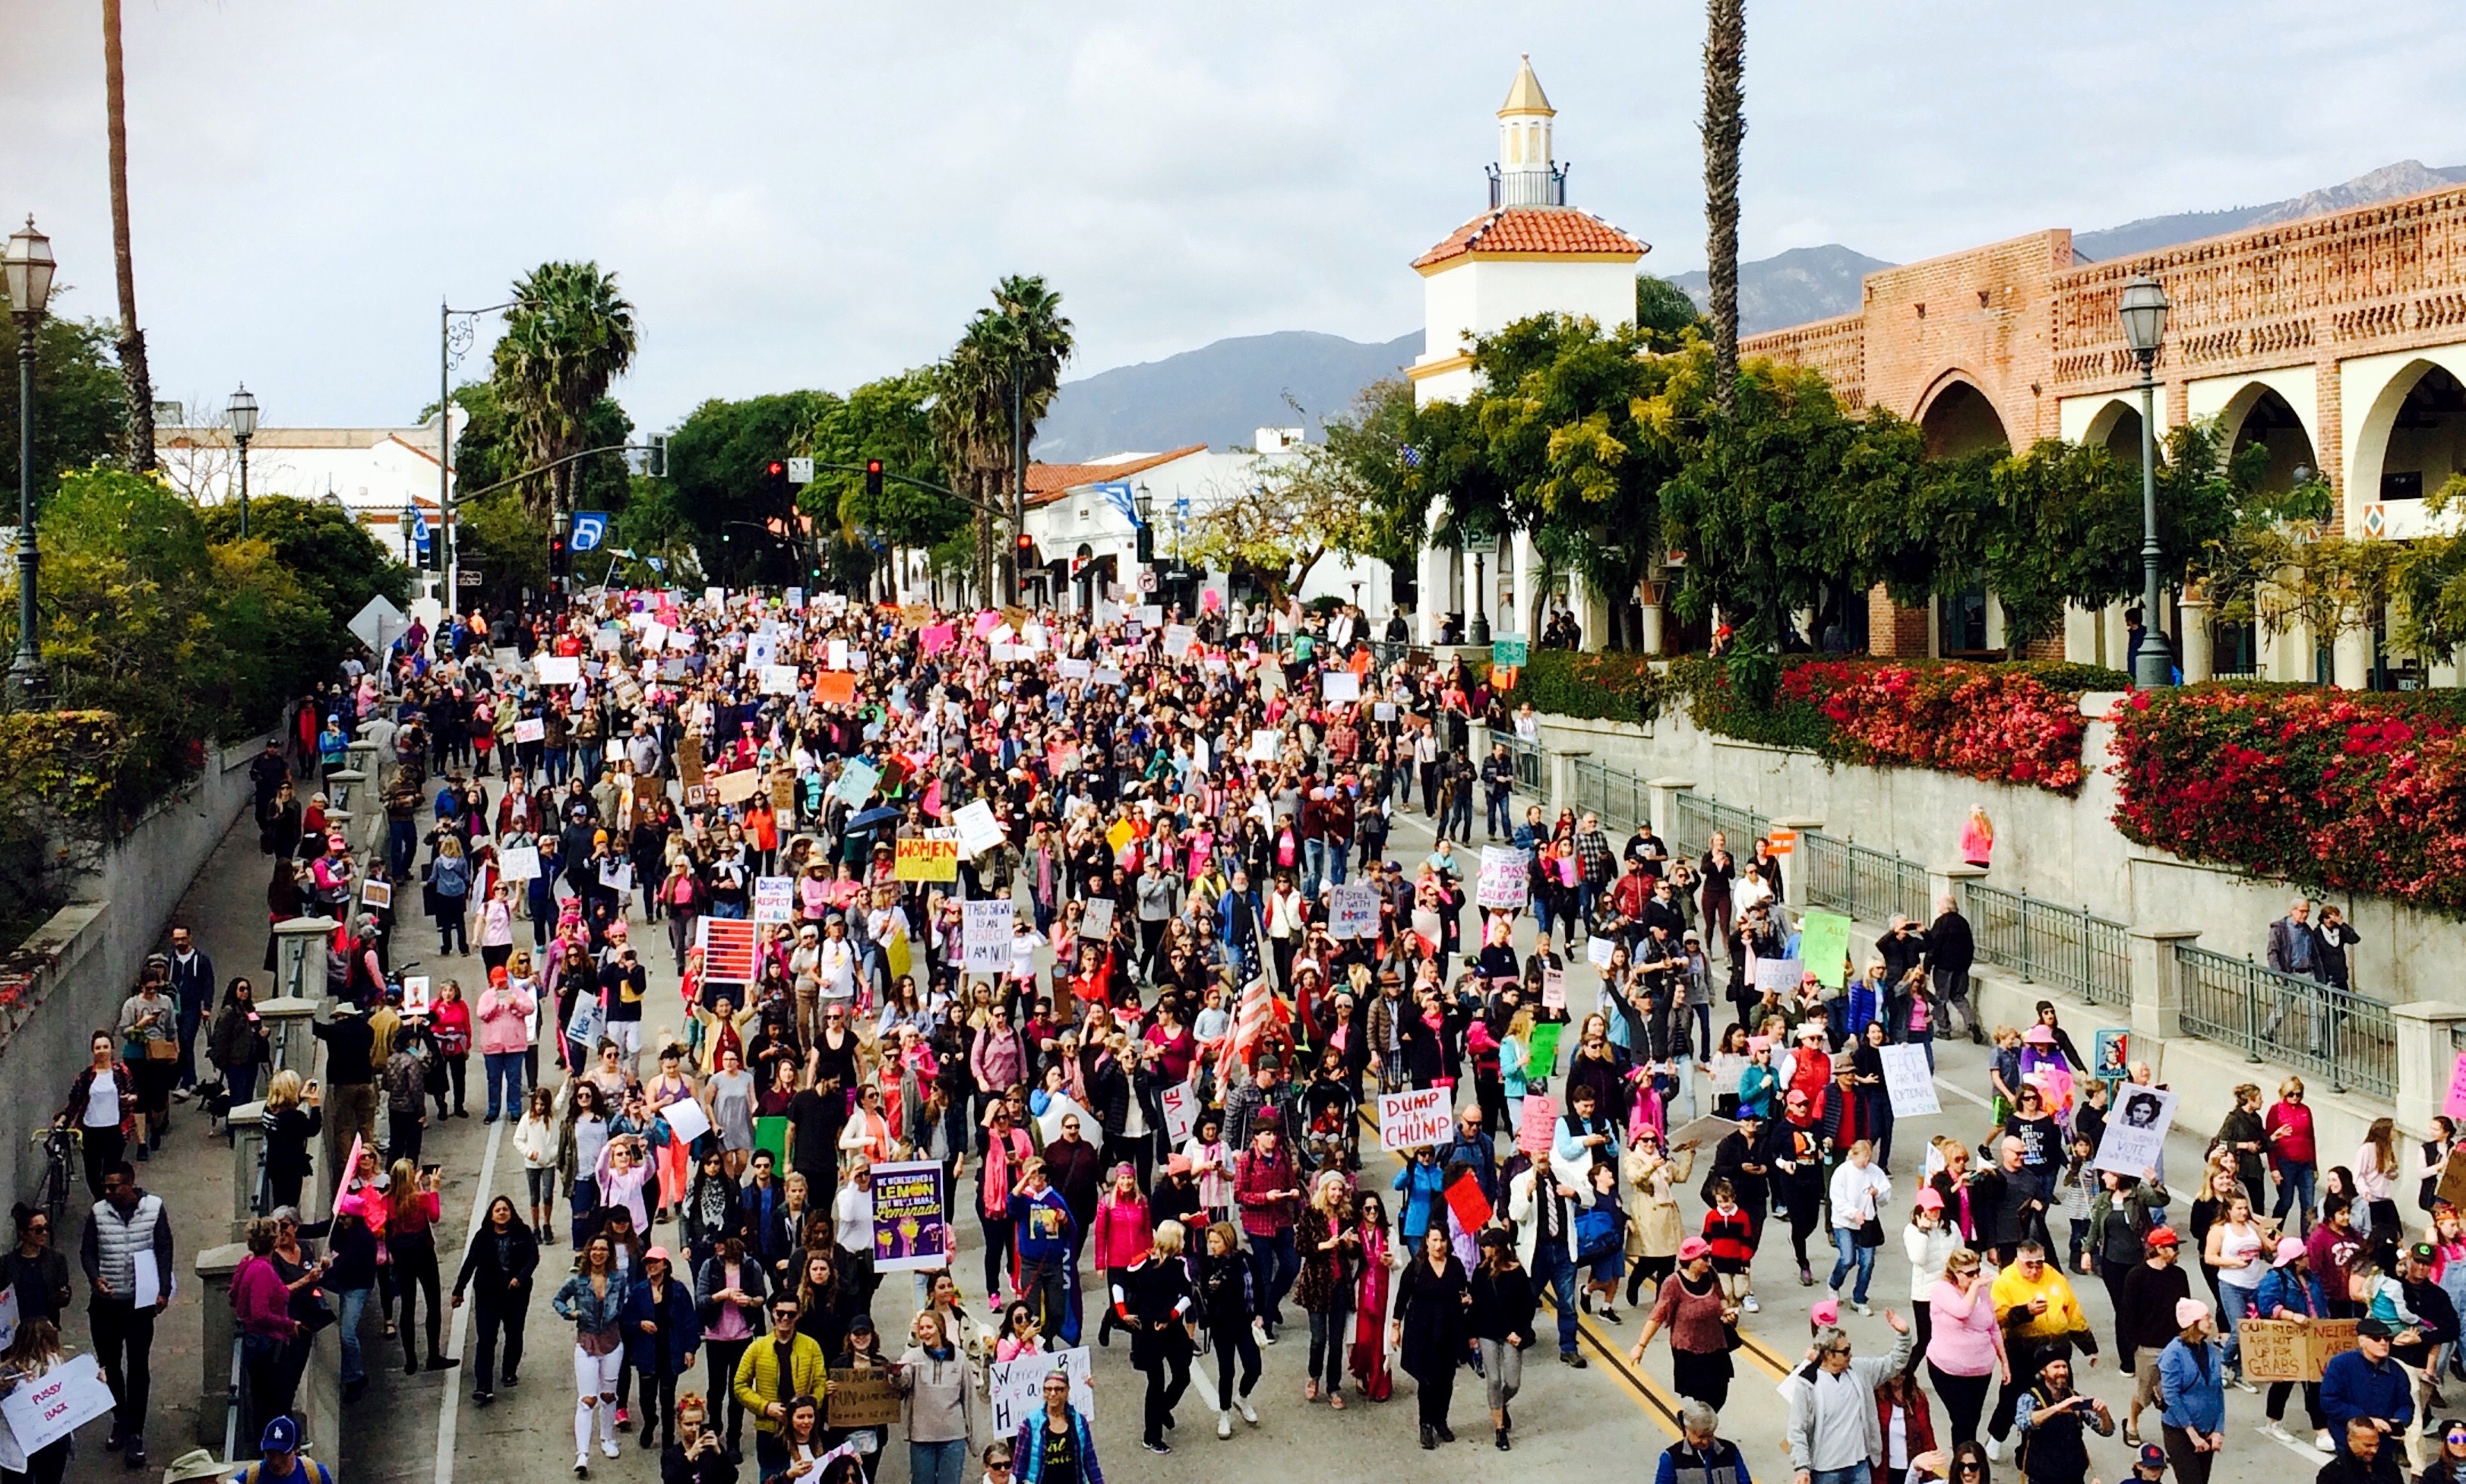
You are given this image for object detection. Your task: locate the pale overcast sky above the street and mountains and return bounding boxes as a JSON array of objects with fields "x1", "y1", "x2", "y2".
[{"x1": 0, "y1": 0, "x2": 2466, "y2": 427}]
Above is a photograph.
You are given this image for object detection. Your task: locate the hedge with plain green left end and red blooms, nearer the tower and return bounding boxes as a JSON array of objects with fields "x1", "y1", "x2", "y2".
[{"x1": 1510, "y1": 651, "x2": 2126, "y2": 794}]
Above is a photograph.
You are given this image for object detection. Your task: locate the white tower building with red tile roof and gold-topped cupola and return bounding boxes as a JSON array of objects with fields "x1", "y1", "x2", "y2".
[{"x1": 1405, "y1": 57, "x2": 1650, "y2": 649}]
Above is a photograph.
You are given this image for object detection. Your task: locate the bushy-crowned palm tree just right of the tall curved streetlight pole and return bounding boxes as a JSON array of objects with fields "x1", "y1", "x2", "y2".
[{"x1": 491, "y1": 264, "x2": 636, "y2": 515}]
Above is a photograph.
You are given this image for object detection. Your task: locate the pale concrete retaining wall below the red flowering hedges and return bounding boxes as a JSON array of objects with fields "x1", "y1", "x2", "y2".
[{"x1": 1541, "y1": 695, "x2": 2466, "y2": 1003}]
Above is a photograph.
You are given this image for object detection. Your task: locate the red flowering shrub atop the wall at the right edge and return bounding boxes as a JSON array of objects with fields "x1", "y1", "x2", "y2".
[{"x1": 2113, "y1": 685, "x2": 2466, "y2": 917}]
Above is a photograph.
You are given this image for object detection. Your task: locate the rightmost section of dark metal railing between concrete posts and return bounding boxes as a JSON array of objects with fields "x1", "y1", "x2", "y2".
[{"x1": 2175, "y1": 944, "x2": 2397, "y2": 1097}]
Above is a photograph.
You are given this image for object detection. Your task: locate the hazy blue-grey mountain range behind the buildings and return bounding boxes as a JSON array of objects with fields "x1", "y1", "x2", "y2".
[{"x1": 1035, "y1": 160, "x2": 2466, "y2": 463}]
